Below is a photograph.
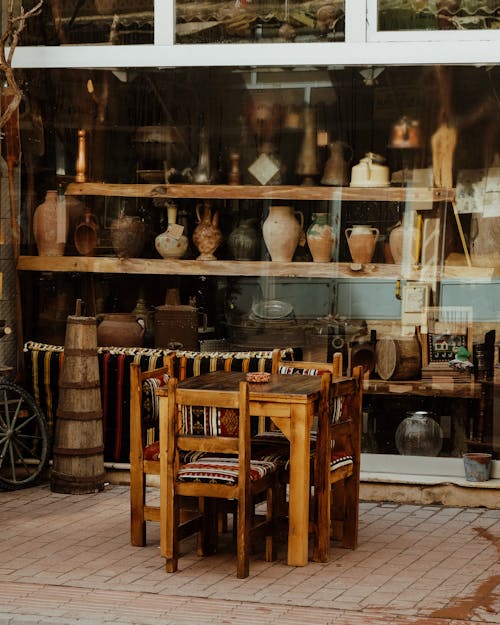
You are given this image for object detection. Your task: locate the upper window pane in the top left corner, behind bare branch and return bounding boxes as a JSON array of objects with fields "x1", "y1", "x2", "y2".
[{"x1": 1, "y1": 0, "x2": 154, "y2": 46}]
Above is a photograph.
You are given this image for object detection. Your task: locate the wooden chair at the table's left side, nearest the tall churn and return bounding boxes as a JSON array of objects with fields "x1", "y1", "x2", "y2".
[{"x1": 130, "y1": 359, "x2": 173, "y2": 547}]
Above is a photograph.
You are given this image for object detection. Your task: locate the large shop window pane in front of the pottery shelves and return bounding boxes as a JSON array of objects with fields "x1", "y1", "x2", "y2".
[{"x1": 2, "y1": 66, "x2": 500, "y2": 461}]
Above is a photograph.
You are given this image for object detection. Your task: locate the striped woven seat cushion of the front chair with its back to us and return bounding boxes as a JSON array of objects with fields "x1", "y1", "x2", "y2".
[{"x1": 177, "y1": 456, "x2": 278, "y2": 486}]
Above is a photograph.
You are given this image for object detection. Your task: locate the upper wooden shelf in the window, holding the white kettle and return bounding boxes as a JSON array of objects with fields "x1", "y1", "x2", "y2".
[{"x1": 66, "y1": 182, "x2": 455, "y2": 202}]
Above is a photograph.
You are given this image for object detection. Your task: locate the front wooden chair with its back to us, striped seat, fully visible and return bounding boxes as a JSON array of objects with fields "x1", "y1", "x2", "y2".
[{"x1": 160, "y1": 378, "x2": 278, "y2": 578}]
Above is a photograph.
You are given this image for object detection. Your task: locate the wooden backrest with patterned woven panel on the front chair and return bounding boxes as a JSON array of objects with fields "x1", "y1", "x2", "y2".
[{"x1": 165, "y1": 378, "x2": 250, "y2": 489}]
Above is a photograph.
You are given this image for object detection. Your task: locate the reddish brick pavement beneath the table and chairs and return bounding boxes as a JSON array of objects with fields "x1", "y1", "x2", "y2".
[{"x1": 0, "y1": 485, "x2": 500, "y2": 625}]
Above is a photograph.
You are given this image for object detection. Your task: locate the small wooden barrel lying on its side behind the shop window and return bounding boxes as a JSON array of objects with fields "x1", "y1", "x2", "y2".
[{"x1": 375, "y1": 336, "x2": 422, "y2": 380}]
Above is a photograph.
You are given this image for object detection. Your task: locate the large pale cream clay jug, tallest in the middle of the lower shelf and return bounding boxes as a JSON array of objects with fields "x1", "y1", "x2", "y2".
[{"x1": 262, "y1": 206, "x2": 304, "y2": 262}]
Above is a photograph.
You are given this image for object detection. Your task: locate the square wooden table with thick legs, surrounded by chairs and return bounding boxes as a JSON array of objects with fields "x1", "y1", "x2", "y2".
[{"x1": 156, "y1": 371, "x2": 321, "y2": 566}]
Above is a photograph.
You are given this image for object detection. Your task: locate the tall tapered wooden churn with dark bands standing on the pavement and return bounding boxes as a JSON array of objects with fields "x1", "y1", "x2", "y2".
[{"x1": 51, "y1": 316, "x2": 105, "y2": 495}]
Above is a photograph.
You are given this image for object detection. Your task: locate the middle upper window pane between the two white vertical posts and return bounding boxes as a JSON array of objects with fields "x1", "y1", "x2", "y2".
[{"x1": 175, "y1": 0, "x2": 345, "y2": 43}]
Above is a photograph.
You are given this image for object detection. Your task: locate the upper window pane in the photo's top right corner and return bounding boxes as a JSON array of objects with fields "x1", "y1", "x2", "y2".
[{"x1": 378, "y1": 0, "x2": 500, "y2": 31}]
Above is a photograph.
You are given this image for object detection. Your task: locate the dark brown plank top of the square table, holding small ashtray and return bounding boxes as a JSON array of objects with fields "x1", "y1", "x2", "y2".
[{"x1": 156, "y1": 371, "x2": 321, "y2": 403}]
